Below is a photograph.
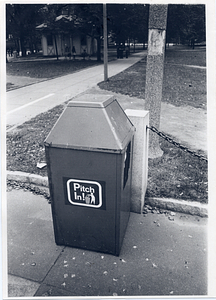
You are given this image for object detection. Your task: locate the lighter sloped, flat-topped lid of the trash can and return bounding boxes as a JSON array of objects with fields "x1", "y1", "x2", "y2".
[{"x1": 45, "y1": 94, "x2": 135, "y2": 153}]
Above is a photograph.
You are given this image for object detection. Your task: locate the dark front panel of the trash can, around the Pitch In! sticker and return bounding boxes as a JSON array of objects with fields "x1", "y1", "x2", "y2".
[{"x1": 46, "y1": 147, "x2": 117, "y2": 254}]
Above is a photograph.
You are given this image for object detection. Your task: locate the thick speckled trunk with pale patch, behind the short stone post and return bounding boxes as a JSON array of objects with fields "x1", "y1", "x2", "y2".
[{"x1": 145, "y1": 4, "x2": 168, "y2": 158}]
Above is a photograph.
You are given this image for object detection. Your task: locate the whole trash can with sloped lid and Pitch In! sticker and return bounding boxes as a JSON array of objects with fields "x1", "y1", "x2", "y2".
[{"x1": 45, "y1": 94, "x2": 135, "y2": 256}]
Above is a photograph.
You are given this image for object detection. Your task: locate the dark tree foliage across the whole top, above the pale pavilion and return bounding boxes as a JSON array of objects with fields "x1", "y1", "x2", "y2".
[{"x1": 6, "y1": 4, "x2": 205, "y2": 60}]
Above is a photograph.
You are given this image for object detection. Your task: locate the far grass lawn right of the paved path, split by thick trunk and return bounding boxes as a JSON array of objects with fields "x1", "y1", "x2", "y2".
[{"x1": 99, "y1": 47, "x2": 207, "y2": 109}]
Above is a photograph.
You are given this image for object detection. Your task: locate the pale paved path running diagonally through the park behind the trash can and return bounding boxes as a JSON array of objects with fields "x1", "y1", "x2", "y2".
[{"x1": 6, "y1": 51, "x2": 147, "y2": 127}]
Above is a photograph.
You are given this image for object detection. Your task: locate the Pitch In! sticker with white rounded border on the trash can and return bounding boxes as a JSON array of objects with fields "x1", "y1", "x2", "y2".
[{"x1": 64, "y1": 178, "x2": 103, "y2": 209}]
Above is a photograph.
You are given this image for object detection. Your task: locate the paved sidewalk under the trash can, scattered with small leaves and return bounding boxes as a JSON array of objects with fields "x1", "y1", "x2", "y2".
[{"x1": 7, "y1": 190, "x2": 207, "y2": 297}]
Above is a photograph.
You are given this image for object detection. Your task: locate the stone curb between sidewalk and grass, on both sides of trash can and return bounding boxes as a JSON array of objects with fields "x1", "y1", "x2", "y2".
[{"x1": 6, "y1": 171, "x2": 208, "y2": 217}]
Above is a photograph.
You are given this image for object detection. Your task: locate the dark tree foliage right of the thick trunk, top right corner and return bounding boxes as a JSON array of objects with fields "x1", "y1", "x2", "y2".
[{"x1": 167, "y1": 4, "x2": 206, "y2": 45}]
